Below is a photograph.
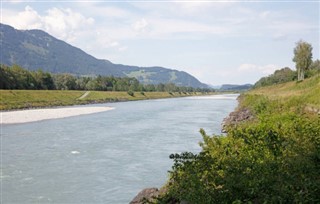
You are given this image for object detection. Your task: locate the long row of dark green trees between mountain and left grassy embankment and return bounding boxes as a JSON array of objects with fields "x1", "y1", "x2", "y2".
[{"x1": 0, "y1": 65, "x2": 213, "y2": 92}]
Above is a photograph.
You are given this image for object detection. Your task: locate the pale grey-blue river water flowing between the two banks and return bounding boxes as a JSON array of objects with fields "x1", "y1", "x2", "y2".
[{"x1": 0, "y1": 95, "x2": 237, "y2": 204}]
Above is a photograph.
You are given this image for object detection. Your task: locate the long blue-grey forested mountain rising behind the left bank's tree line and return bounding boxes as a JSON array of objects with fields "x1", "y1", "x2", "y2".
[{"x1": 0, "y1": 24, "x2": 208, "y2": 88}]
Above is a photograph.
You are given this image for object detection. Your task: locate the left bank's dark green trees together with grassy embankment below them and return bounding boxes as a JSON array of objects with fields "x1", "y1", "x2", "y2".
[{"x1": 0, "y1": 65, "x2": 214, "y2": 110}]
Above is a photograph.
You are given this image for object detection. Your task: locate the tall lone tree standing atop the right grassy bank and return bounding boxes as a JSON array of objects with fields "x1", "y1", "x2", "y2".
[{"x1": 292, "y1": 40, "x2": 312, "y2": 81}]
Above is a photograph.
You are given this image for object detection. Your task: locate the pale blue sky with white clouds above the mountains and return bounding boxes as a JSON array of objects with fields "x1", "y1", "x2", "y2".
[{"x1": 1, "y1": 0, "x2": 320, "y2": 85}]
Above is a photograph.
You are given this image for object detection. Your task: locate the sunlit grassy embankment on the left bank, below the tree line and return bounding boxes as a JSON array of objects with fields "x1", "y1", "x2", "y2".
[{"x1": 0, "y1": 90, "x2": 212, "y2": 110}]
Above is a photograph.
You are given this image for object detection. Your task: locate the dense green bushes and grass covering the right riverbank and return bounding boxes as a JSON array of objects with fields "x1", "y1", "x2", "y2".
[{"x1": 158, "y1": 77, "x2": 320, "y2": 204}]
